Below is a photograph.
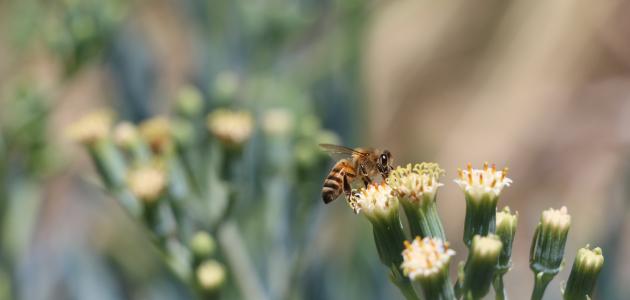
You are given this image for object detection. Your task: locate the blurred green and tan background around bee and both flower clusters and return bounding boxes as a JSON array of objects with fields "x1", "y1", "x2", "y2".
[{"x1": 0, "y1": 0, "x2": 630, "y2": 299}]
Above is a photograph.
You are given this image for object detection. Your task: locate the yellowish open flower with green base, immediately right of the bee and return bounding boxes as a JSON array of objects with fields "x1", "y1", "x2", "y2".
[{"x1": 387, "y1": 163, "x2": 446, "y2": 240}]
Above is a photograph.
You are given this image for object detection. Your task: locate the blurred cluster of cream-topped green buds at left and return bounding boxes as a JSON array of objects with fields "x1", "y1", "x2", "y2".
[{"x1": 67, "y1": 94, "x2": 256, "y2": 297}]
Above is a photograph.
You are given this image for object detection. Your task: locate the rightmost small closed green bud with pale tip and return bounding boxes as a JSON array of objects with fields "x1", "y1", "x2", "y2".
[{"x1": 563, "y1": 245, "x2": 604, "y2": 300}]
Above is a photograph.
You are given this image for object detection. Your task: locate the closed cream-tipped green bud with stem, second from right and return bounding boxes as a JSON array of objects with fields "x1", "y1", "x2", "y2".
[{"x1": 529, "y1": 206, "x2": 571, "y2": 299}]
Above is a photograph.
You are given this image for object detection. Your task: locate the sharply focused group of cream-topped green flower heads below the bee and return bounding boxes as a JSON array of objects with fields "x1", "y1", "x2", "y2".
[{"x1": 338, "y1": 163, "x2": 603, "y2": 299}]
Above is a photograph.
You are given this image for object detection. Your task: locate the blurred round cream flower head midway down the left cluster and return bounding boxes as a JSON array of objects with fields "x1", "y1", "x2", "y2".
[{"x1": 127, "y1": 166, "x2": 167, "y2": 202}]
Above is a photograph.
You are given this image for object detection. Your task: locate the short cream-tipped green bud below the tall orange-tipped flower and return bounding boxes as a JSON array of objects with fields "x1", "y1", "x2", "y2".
[{"x1": 460, "y1": 235, "x2": 503, "y2": 299}]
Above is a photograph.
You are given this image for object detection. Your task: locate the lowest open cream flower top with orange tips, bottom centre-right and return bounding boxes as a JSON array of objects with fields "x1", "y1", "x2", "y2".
[{"x1": 400, "y1": 237, "x2": 455, "y2": 280}]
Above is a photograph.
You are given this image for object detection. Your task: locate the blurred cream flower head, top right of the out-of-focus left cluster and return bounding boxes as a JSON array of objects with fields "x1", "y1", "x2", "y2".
[{"x1": 208, "y1": 109, "x2": 254, "y2": 146}]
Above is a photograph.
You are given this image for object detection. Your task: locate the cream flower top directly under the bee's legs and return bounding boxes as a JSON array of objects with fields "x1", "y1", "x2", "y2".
[{"x1": 348, "y1": 184, "x2": 398, "y2": 217}]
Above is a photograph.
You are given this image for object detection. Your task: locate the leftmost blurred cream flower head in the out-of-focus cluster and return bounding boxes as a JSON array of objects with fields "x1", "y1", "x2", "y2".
[{"x1": 66, "y1": 109, "x2": 113, "y2": 145}]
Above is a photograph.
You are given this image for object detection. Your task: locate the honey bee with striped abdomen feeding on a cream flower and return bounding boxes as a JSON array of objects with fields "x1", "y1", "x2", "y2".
[{"x1": 319, "y1": 144, "x2": 393, "y2": 204}]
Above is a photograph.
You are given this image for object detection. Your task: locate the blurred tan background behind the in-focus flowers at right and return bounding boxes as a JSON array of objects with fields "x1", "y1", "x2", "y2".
[{"x1": 365, "y1": 0, "x2": 630, "y2": 299}]
